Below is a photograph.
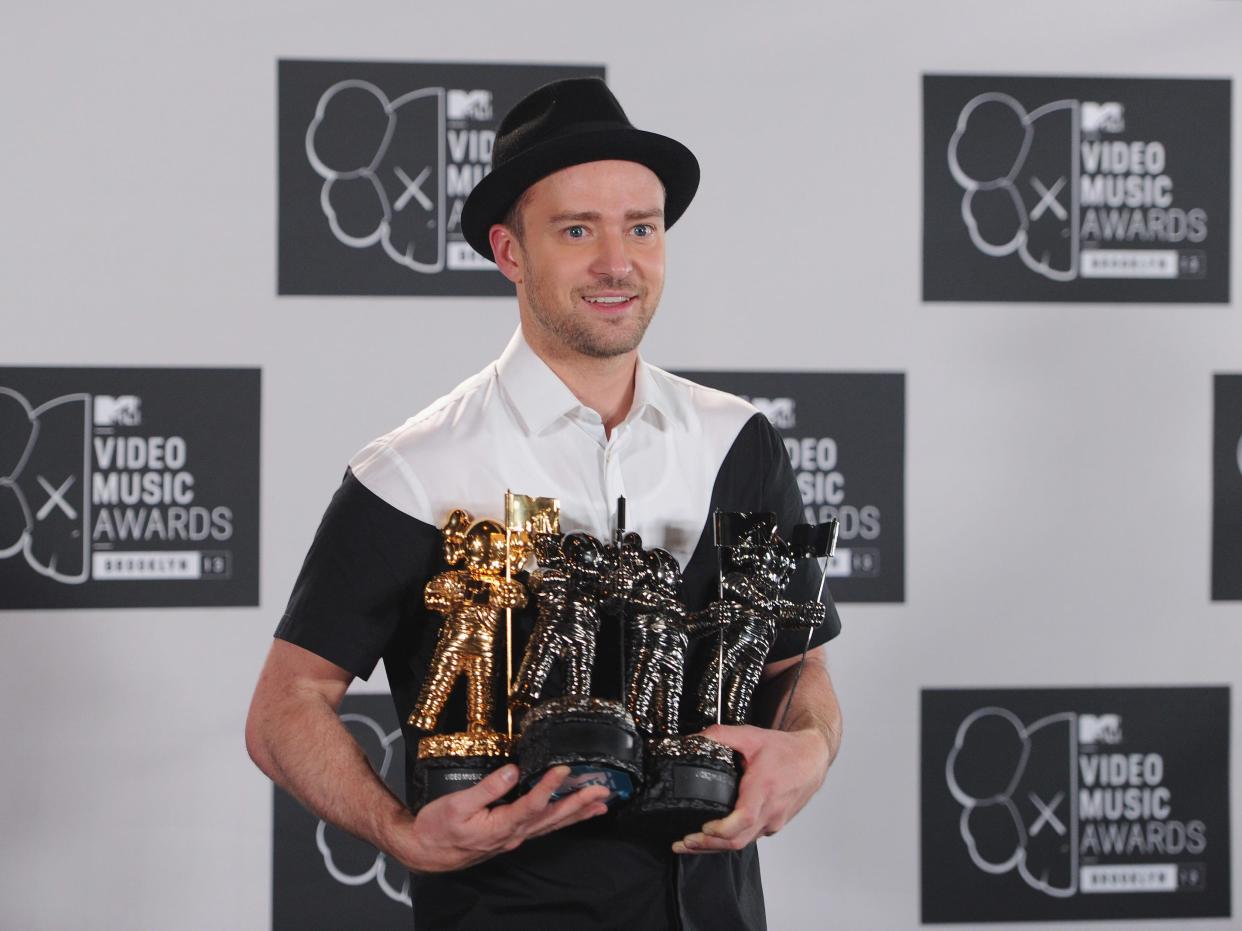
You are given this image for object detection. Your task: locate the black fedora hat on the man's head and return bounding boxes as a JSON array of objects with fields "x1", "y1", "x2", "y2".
[{"x1": 462, "y1": 78, "x2": 699, "y2": 259}]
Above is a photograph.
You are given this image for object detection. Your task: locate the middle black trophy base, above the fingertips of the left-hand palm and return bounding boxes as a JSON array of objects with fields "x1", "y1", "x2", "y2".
[{"x1": 514, "y1": 698, "x2": 642, "y2": 806}]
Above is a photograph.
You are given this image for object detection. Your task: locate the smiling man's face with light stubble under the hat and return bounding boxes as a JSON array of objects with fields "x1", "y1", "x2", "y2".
[{"x1": 502, "y1": 161, "x2": 664, "y2": 359}]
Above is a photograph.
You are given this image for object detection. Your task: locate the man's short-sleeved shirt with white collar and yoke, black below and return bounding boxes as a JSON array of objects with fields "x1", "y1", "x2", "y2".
[{"x1": 276, "y1": 329, "x2": 841, "y2": 929}]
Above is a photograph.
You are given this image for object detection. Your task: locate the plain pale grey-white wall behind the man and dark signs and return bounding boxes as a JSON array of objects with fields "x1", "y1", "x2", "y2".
[{"x1": 0, "y1": 0, "x2": 1242, "y2": 929}]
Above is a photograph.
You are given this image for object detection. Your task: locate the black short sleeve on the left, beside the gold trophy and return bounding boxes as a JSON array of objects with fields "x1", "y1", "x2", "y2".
[{"x1": 276, "y1": 472, "x2": 441, "y2": 679}]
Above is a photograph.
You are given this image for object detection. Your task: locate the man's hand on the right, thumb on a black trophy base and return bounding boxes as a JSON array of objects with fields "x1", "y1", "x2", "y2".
[{"x1": 673, "y1": 724, "x2": 831, "y2": 854}]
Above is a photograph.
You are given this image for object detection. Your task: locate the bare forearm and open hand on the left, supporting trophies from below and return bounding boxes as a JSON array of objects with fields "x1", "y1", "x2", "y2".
[{"x1": 246, "y1": 639, "x2": 607, "y2": 873}]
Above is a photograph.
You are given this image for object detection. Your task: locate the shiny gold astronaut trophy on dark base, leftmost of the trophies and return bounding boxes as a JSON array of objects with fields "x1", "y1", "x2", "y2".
[{"x1": 409, "y1": 509, "x2": 529, "y2": 808}]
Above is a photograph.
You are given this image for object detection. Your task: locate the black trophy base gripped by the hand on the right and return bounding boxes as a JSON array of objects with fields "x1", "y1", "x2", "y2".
[{"x1": 628, "y1": 735, "x2": 739, "y2": 840}]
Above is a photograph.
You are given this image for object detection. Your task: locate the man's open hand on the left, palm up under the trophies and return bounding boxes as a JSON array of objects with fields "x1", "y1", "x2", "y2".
[{"x1": 386, "y1": 763, "x2": 609, "y2": 873}]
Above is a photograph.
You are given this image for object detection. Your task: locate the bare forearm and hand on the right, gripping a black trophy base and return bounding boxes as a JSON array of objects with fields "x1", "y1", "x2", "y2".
[{"x1": 673, "y1": 647, "x2": 842, "y2": 853}]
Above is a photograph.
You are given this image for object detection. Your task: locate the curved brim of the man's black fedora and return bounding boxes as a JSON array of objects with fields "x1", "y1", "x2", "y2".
[{"x1": 461, "y1": 127, "x2": 699, "y2": 262}]
